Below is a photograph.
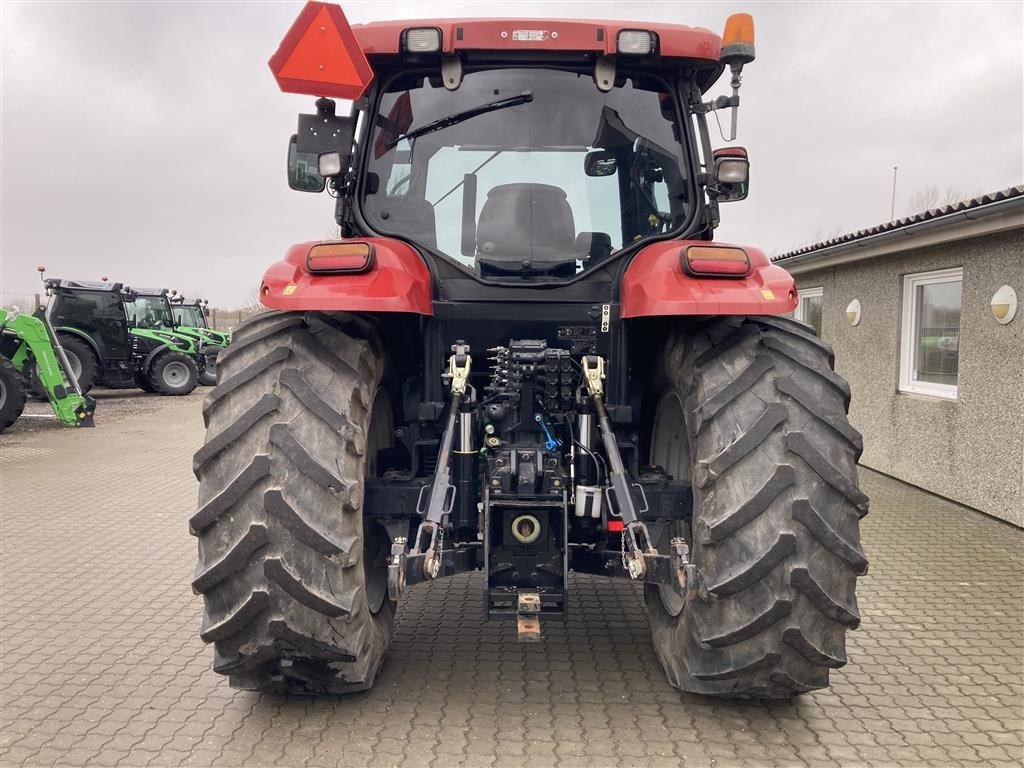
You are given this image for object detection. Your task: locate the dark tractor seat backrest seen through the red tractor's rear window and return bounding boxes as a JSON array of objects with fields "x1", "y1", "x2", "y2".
[{"x1": 476, "y1": 183, "x2": 575, "y2": 274}]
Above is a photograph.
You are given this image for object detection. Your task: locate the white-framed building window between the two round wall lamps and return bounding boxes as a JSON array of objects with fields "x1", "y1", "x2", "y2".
[{"x1": 899, "y1": 268, "x2": 964, "y2": 399}]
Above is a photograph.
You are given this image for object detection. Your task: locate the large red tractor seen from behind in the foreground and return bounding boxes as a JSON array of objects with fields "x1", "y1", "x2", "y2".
[{"x1": 190, "y1": 2, "x2": 867, "y2": 698}]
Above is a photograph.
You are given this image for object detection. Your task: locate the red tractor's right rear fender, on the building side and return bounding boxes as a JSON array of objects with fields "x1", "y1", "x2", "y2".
[{"x1": 622, "y1": 240, "x2": 797, "y2": 318}]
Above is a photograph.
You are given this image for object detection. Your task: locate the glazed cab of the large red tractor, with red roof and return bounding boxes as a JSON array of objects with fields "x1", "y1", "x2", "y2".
[{"x1": 270, "y1": 13, "x2": 753, "y2": 290}]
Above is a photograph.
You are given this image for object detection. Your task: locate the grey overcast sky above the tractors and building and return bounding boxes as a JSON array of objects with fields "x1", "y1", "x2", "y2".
[{"x1": 0, "y1": 0, "x2": 1024, "y2": 307}]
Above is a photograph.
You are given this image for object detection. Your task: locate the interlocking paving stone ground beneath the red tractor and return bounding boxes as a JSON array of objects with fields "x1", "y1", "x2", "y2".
[{"x1": 0, "y1": 392, "x2": 1024, "y2": 768}]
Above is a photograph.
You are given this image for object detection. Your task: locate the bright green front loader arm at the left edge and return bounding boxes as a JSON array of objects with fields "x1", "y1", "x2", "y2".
[{"x1": 0, "y1": 309, "x2": 96, "y2": 432}]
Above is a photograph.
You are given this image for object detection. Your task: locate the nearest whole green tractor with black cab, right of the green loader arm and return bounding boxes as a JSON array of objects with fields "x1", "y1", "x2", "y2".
[{"x1": 43, "y1": 278, "x2": 199, "y2": 395}]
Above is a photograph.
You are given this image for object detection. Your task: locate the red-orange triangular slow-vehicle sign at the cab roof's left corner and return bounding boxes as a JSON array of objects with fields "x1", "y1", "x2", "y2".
[{"x1": 268, "y1": 2, "x2": 374, "y2": 99}]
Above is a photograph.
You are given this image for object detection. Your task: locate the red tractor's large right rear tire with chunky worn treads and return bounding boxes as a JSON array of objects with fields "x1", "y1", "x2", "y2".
[{"x1": 644, "y1": 317, "x2": 867, "y2": 698}]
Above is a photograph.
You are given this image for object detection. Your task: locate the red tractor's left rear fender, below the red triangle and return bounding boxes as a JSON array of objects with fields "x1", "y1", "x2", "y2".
[{"x1": 259, "y1": 238, "x2": 433, "y2": 314}]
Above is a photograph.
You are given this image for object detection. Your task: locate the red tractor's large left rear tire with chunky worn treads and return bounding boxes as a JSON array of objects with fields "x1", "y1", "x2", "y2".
[{"x1": 190, "y1": 312, "x2": 394, "y2": 693}]
